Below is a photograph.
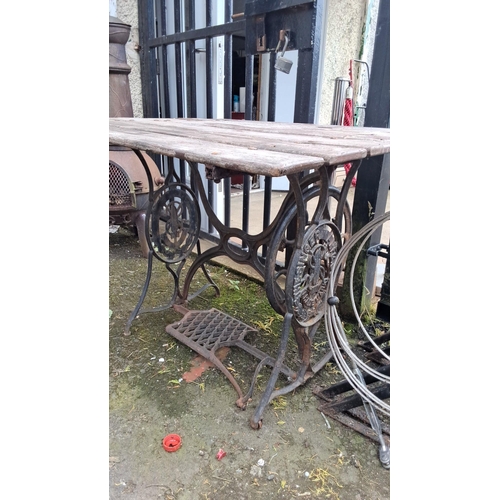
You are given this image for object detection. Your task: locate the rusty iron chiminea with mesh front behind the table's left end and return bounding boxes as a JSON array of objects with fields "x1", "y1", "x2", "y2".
[{"x1": 109, "y1": 16, "x2": 165, "y2": 257}]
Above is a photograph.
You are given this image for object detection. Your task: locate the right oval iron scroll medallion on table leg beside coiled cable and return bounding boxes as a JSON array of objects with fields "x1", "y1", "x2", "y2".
[{"x1": 286, "y1": 220, "x2": 342, "y2": 327}]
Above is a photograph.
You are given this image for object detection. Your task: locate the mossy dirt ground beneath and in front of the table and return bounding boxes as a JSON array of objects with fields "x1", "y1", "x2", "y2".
[{"x1": 109, "y1": 229, "x2": 390, "y2": 500}]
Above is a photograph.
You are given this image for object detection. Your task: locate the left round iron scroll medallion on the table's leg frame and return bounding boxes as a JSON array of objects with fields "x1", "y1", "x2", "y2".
[{"x1": 146, "y1": 183, "x2": 201, "y2": 264}]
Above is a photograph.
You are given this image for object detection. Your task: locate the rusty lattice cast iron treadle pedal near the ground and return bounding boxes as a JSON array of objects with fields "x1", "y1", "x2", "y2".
[{"x1": 166, "y1": 306, "x2": 296, "y2": 408}]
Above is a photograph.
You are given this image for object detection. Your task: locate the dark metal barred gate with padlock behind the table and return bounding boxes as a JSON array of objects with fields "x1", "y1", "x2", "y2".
[{"x1": 138, "y1": 0, "x2": 324, "y2": 249}]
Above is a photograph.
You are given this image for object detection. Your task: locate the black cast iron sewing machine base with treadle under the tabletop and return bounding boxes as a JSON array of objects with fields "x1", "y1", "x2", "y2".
[{"x1": 124, "y1": 161, "x2": 359, "y2": 429}]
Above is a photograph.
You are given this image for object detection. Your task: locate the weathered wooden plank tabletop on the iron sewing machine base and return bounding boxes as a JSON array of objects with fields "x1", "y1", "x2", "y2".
[{"x1": 109, "y1": 118, "x2": 390, "y2": 177}]
